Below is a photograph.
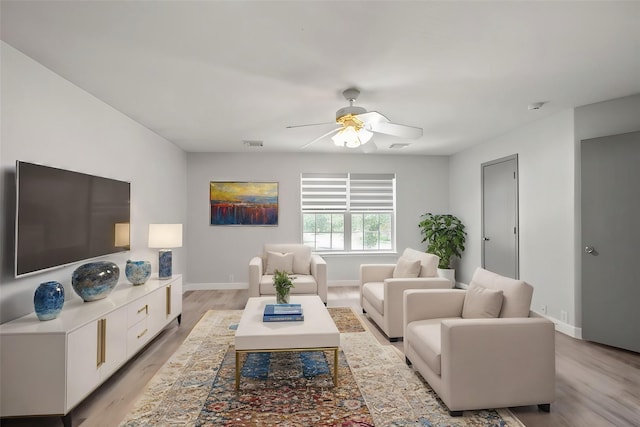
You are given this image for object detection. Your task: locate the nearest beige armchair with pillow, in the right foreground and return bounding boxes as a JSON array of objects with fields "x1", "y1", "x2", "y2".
[{"x1": 404, "y1": 268, "x2": 555, "y2": 416}]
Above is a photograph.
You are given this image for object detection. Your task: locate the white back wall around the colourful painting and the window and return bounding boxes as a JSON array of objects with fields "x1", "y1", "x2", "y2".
[{"x1": 187, "y1": 152, "x2": 449, "y2": 287}]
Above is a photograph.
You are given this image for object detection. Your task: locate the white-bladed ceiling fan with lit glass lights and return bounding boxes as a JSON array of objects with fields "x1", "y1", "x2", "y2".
[{"x1": 287, "y1": 88, "x2": 422, "y2": 149}]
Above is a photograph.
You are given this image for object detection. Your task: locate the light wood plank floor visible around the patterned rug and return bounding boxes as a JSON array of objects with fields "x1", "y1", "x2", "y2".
[{"x1": 0, "y1": 287, "x2": 640, "y2": 427}]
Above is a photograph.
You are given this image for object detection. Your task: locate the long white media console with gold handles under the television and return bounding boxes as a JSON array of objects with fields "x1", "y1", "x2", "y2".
[{"x1": 0, "y1": 275, "x2": 182, "y2": 426}]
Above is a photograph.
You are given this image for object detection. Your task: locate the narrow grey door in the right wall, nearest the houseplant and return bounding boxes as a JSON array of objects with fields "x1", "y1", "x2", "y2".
[{"x1": 482, "y1": 154, "x2": 520, "y2": 279}]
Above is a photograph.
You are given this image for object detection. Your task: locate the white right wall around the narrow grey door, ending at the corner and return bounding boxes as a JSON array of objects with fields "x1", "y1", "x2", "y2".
[{"x1": 449, "y1": 110, "x2": 576, "y2": 325}]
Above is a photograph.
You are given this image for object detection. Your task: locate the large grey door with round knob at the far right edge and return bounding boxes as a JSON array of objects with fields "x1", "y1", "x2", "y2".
[{"x1": 581, "y1": 132, "x2": 640, "y2": 352}]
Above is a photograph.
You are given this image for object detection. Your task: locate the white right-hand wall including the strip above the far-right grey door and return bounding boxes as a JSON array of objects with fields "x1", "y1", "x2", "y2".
[{"x1": 449, "y1": 95, "x2": 640, "y2": 337}]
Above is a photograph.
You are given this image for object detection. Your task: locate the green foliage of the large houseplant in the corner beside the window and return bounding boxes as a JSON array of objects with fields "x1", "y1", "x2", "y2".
[{"x1": 418, "y1": 213, "x2": 467, "y2": 269}]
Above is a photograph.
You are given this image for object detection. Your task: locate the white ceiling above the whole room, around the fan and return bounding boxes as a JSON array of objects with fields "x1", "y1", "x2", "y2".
[{"x1": 0, "y1": 0, "x2": 640, "y2": 155}]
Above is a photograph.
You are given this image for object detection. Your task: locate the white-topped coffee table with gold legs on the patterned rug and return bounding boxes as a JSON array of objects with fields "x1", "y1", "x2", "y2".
[{"x1": 235, "y1": 295, "x2": 340, "y2": 390}]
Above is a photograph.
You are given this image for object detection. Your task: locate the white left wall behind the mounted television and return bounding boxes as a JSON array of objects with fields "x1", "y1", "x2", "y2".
[{"x1": 0, "y1": 42, "x2": 186, "y2": 322}]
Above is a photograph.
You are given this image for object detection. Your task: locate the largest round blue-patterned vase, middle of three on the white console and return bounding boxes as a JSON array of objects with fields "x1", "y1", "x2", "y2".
[{"x1": 71, "y1": 261, "x2": 120, "y2": 302}]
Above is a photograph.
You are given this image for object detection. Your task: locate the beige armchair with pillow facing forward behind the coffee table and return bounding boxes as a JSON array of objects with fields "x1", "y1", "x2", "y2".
[{"x1": 249, "y1": 243, "x2": 327, "y2": 304}]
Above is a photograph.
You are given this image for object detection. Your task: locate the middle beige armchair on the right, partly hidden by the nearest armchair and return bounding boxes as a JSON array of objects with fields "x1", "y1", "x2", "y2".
[{"x1": 360, "y1": 248, "x2": 453, "y2": 341}]
